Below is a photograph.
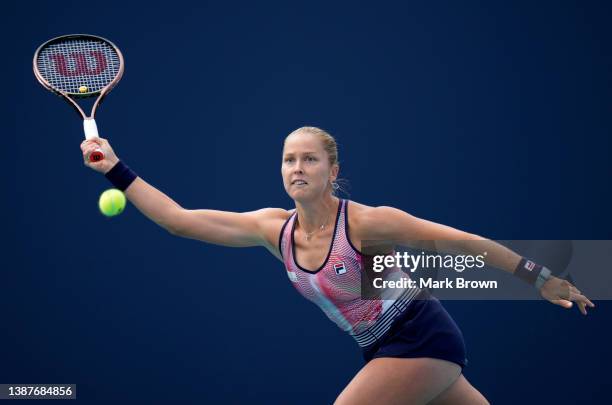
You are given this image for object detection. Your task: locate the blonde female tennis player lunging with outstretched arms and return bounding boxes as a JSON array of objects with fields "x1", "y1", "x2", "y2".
[{"x1": 81, "y1": 127, "x2": 594, "y2": 405}]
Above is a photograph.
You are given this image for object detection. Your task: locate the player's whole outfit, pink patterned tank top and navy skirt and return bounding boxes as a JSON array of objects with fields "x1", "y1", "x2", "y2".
[{"x1": 279, "y1": 200, "x2": 467, "y2": 368}]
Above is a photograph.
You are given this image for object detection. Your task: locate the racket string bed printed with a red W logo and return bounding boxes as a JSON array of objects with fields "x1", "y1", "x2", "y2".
[{"x1": 36, "y1": 39, "x2": 121, "y2": 94}]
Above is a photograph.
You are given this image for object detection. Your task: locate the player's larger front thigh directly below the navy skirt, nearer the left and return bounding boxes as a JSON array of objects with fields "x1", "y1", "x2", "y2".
[{"x1": 335, "y1": 357, "x2": 461, "y2": 405}]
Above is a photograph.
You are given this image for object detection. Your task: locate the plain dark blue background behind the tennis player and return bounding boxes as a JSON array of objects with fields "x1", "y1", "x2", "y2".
[{"x1": 0, "y1": 1, "x2": 612, "y2": 404}]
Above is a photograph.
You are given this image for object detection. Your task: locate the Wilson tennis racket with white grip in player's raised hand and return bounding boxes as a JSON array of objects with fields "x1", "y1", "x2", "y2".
[{"x1": 33, "y1": 34, "x2": 123, "y2": 162}]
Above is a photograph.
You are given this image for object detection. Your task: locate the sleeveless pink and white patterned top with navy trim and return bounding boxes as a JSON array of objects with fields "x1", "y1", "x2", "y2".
[{"x1": 279, "y1": 199, "x2": 420, "y2": 347}]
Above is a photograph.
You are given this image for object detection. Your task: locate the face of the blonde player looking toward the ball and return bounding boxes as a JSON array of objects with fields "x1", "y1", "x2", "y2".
[{"x1": 281, "y1": 133, "x2": 338, "y2": 201}]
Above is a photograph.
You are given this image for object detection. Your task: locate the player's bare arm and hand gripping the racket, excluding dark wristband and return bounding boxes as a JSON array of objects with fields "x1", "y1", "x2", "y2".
[{"x1": 81, "y1": 138, "x2": 289, "y2": 252}]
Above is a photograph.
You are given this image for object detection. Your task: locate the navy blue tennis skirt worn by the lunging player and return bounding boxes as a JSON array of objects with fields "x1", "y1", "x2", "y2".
[{"x1": 363, "y1": 290, "x2": 467, "y2": 370}]
